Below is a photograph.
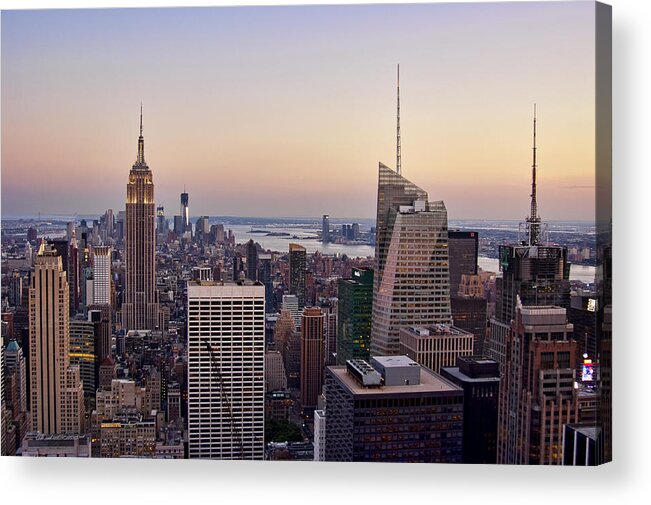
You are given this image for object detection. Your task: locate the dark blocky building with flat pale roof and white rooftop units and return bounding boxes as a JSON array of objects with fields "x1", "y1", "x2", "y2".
[{"x1": 325, "y1": 356, "x2": 463, "y2": 463}]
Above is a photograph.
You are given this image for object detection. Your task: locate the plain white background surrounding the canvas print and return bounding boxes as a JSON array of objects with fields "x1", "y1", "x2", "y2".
[{"x1": 0, "y1": 0, "x2": 651, "y2": 505}]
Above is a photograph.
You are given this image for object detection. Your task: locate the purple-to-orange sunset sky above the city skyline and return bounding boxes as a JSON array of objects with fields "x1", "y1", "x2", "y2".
[{"x1": 1, "y1": 2, "x2": 595, "y2": 220}]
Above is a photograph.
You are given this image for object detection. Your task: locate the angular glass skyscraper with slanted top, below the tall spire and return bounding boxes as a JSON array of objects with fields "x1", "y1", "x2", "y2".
[{"x1": 371, "y1": 163, "x2": 452, "y2": 355}]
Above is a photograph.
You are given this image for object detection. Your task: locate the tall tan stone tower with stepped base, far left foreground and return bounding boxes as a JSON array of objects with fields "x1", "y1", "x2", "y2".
[{"x1": 29, "y1": 243, "x2": 84, "y2": 435}]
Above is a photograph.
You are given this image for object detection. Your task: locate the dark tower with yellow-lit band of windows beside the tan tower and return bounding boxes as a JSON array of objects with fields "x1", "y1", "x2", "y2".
[{"x1": 70, "y1": 319, "x2": 99, "y2": 406}]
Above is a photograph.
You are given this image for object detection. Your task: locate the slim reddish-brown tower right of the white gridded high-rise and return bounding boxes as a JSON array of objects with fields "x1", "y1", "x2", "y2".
[{"x1": 301, "y1": 307, "x2": 325, "y2": 414}]
